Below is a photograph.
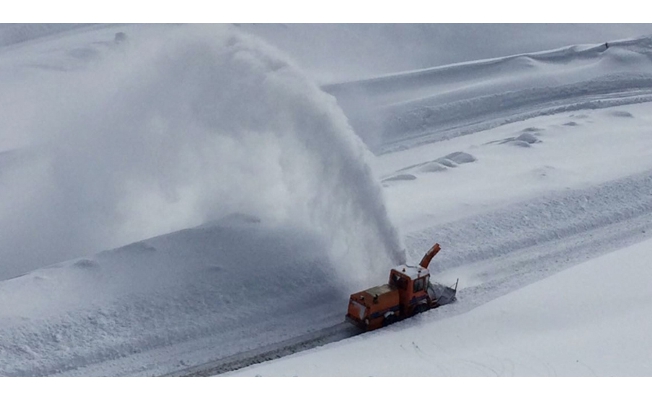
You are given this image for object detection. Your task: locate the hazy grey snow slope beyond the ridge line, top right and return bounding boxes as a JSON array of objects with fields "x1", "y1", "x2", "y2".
[{"x1": 238, "y1": 23, "x2": 652, "y2": 82}]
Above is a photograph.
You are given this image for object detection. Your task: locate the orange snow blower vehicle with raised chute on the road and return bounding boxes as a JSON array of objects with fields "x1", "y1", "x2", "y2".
[{"x1": 345, "y1": 243, "x2": 459, "y2": 331}]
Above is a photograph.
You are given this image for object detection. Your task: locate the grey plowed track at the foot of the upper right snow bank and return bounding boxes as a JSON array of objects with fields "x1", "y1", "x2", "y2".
[{"x1": 377, "y1": 74, "x2": 652, "y2": 154}]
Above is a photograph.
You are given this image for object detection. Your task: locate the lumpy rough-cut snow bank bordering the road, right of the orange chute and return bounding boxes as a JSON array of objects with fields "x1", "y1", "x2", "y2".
[{"x1": 406, "y1": 171, "x2": 652, "y2": 270}]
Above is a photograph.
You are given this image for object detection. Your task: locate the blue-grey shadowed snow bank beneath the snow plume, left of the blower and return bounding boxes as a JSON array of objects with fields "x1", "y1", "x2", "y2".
[{"x1": 0, "y1": 223, "x2": 348, "y2": 376}]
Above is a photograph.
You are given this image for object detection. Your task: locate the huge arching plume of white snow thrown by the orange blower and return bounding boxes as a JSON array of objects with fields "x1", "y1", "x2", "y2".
[{"x1": 0, "y1": 26, "x2": 404, "y2": 279}]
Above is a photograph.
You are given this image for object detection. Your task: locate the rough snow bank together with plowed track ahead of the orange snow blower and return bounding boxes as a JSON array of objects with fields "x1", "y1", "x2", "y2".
[{"x1": 406, "y1": 171, "x2": 652, "y2": 318}]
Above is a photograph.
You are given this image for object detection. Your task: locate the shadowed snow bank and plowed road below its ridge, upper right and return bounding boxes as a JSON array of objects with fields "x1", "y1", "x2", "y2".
[{"x1": 326, "y1": 37, "x2": 652, "y2": 153}]
